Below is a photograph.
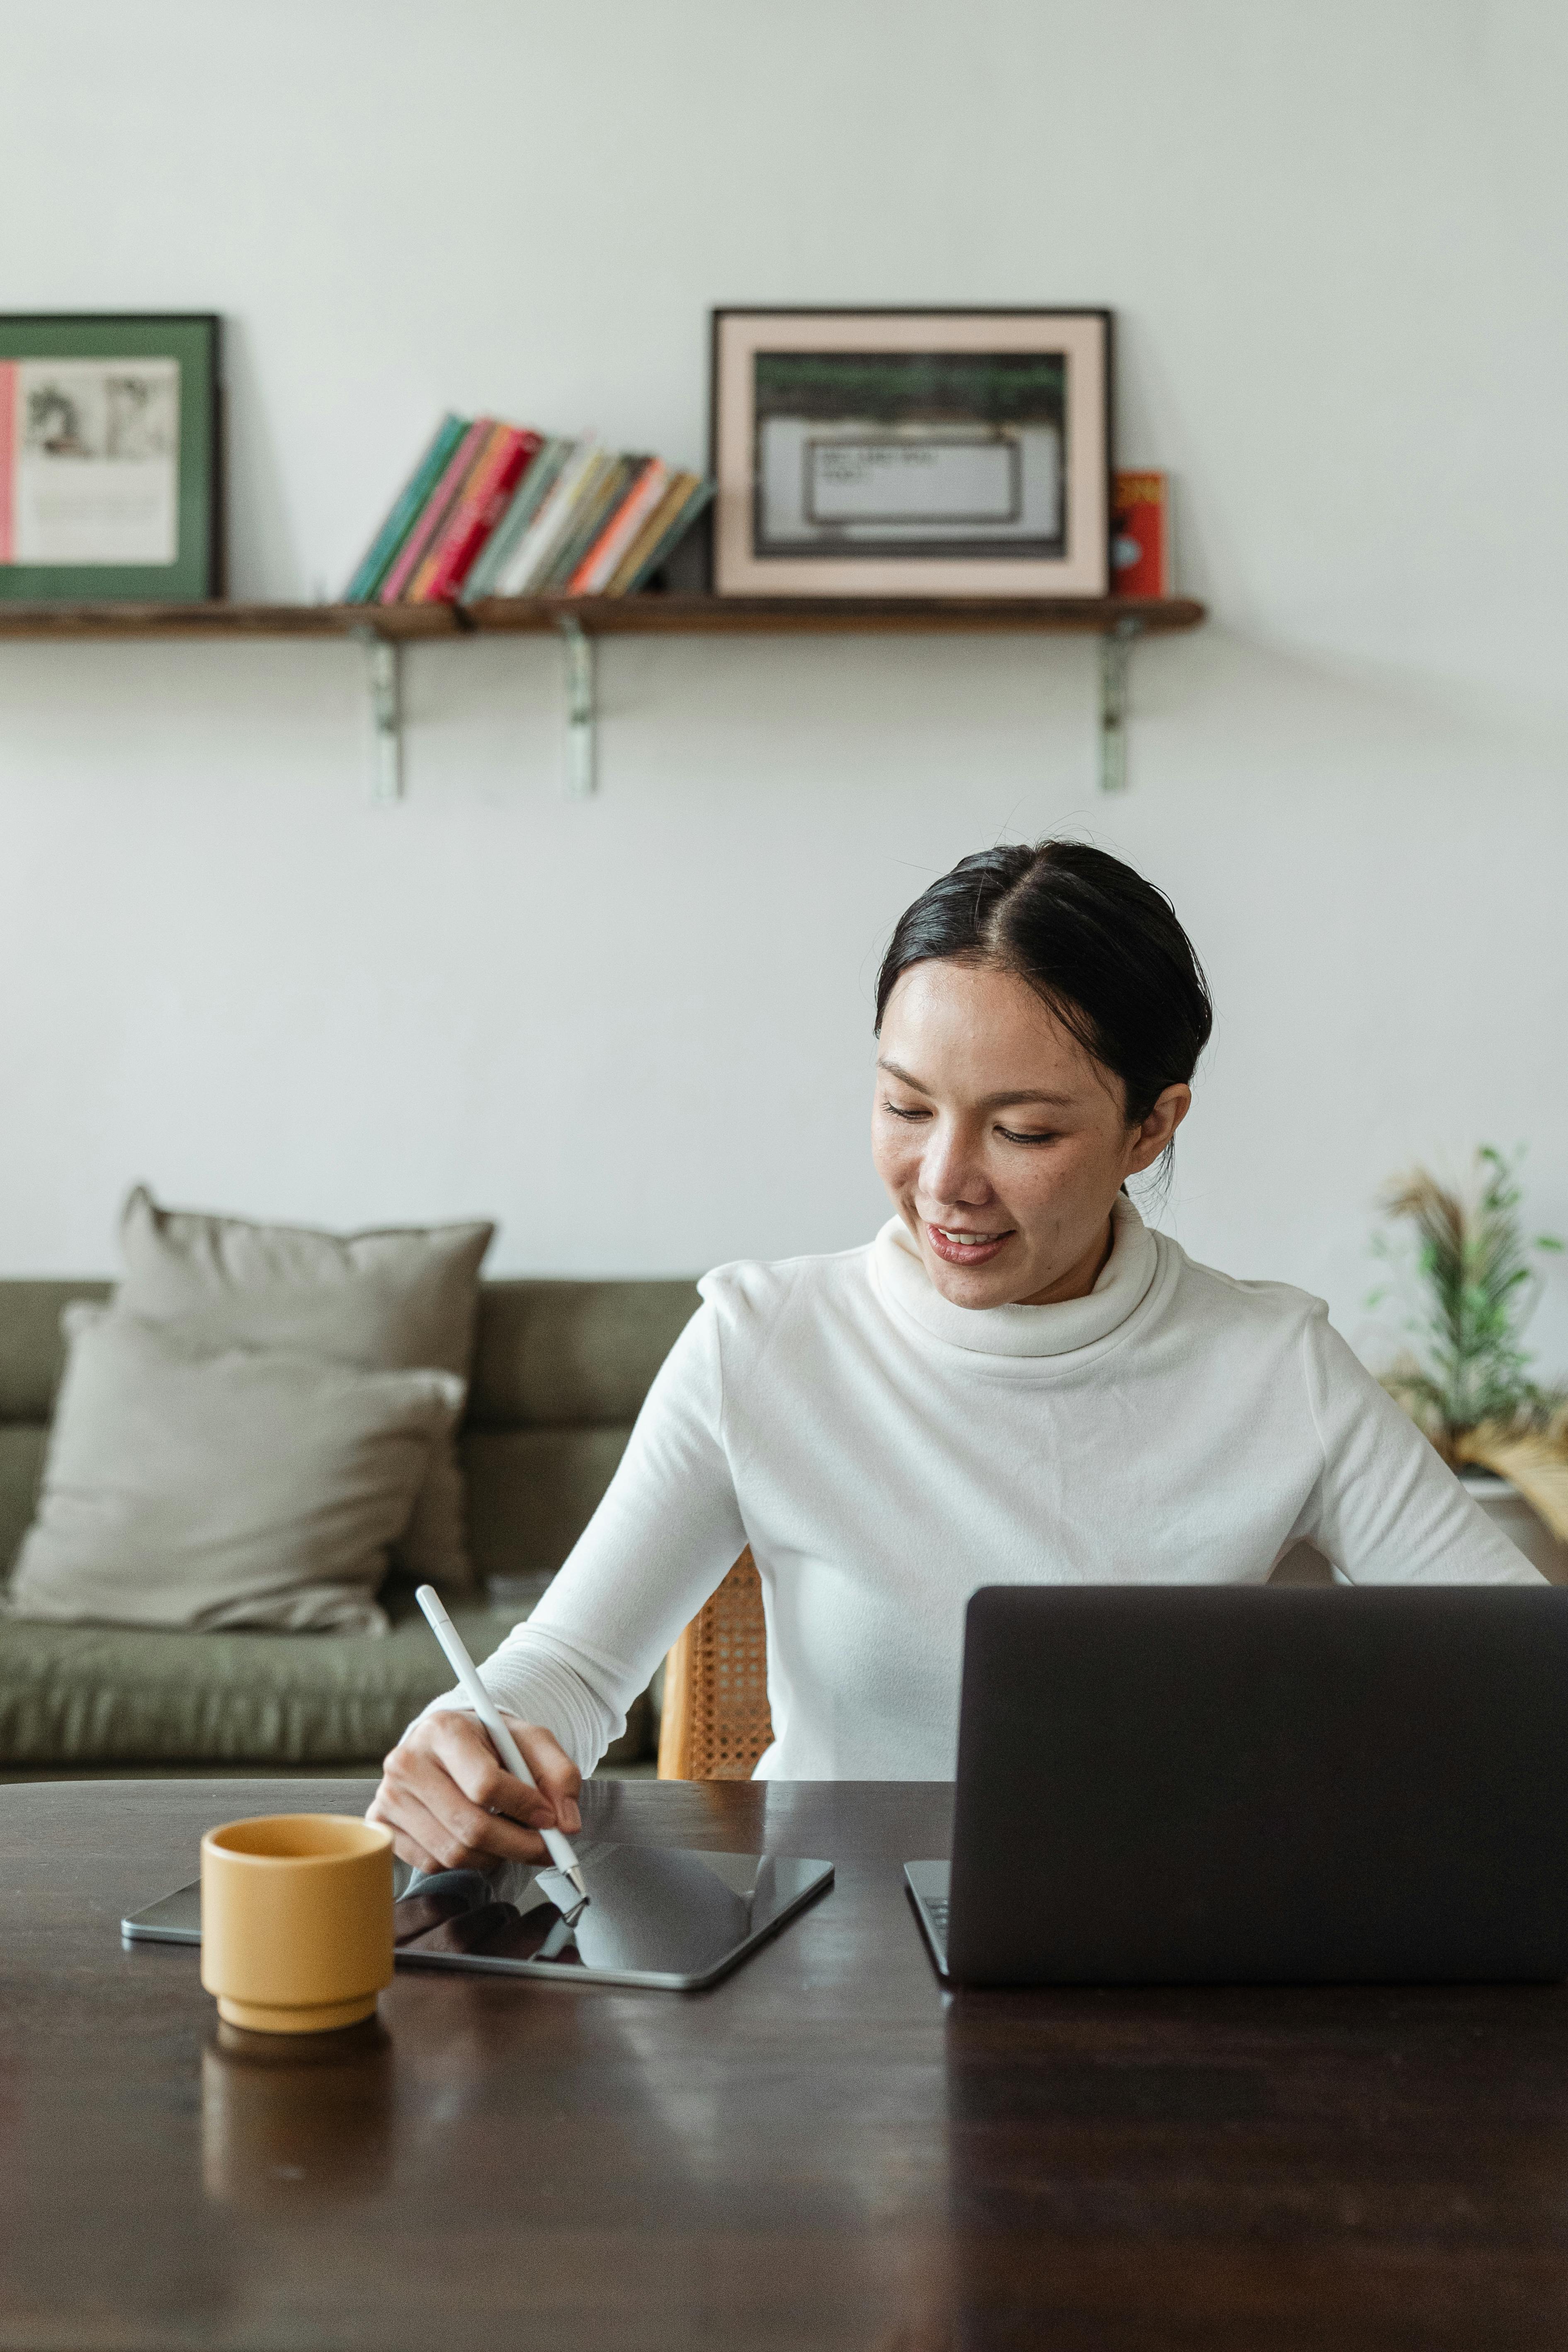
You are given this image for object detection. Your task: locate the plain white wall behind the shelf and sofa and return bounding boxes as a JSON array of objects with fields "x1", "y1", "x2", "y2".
[{"x1": 0, "y1": 0, "x2": 1568, "y2": 1364}]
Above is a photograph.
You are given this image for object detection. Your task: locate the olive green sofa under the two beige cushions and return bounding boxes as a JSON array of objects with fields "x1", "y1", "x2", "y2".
[{"x1": 0, "y1": 1282, "x2": 696, "y2": 1780}]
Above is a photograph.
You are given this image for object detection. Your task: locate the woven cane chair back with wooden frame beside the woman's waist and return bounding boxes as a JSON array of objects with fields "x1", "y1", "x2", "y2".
[{"x1": 658, "y1": 1550, "x2": 773, "y2": 1780}]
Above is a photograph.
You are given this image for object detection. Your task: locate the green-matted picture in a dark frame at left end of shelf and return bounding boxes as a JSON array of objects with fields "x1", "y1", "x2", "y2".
[{"x1": 0, "y1": 311, "x2": 223, "y2": 604}]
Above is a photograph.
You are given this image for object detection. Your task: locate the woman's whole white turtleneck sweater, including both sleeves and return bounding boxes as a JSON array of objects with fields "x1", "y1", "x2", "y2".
[{"x1": 435, "y1": 1202, "x2": 1537, "y2": 1780}]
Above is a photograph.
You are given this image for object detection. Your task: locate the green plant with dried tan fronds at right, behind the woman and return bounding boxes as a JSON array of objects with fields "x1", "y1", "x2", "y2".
[{"x1": 1368, "y1": 1143, "x2": 1568, "y2": 1543}]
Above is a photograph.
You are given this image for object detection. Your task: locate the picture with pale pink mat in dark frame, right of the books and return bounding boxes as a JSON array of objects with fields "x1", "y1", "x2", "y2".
[{"x1": 712, "y1": 311, "x2": 1112, "y2": 597}]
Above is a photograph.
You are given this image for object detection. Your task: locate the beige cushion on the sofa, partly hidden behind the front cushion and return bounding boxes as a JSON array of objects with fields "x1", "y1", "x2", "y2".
[{"x1": 115, "y1": 1185, "x2": 496, "y2": 1590}]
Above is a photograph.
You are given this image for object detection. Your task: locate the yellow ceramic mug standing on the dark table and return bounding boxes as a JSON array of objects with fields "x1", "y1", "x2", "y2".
[{"x1": 202, "y1": 1813, "x2": 393, "y2": 2034}]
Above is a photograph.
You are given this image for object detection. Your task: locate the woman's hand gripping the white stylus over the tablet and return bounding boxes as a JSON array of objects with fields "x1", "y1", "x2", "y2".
[{"x1": 364, "y1": 1708, "x2": 583, "y2": 1870}]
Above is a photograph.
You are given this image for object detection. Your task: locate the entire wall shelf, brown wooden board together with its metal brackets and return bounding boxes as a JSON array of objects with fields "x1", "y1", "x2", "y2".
[{"x1": 0, "y1": 595, "x2": 1206, "y2": 802}]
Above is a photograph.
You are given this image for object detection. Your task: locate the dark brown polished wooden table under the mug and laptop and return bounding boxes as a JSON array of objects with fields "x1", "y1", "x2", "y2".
[{"x1": 0, "y1": 1780, "x2": 1568, "y2": 2352}]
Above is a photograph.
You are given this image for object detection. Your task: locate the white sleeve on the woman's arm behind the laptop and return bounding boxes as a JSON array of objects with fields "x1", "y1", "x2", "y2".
[{"x1": 1295, "y1": 1308, "x2": 1542, "y2": 1585}]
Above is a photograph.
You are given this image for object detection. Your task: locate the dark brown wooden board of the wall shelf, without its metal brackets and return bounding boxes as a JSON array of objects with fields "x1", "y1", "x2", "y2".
[{"x1": 0, "y1": 595, "x2": 1206, "y2": 644}]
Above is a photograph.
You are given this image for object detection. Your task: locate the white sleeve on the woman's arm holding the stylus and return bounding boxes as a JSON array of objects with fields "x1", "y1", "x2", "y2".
[{"x1": 425, "y1": 1306, "x2": 745, "y2": 1773}]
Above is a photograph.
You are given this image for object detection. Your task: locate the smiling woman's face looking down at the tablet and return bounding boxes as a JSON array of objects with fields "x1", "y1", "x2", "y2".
[{"x1": 872, "y1": 960, "x2": 1192, "y2": 1308}]
